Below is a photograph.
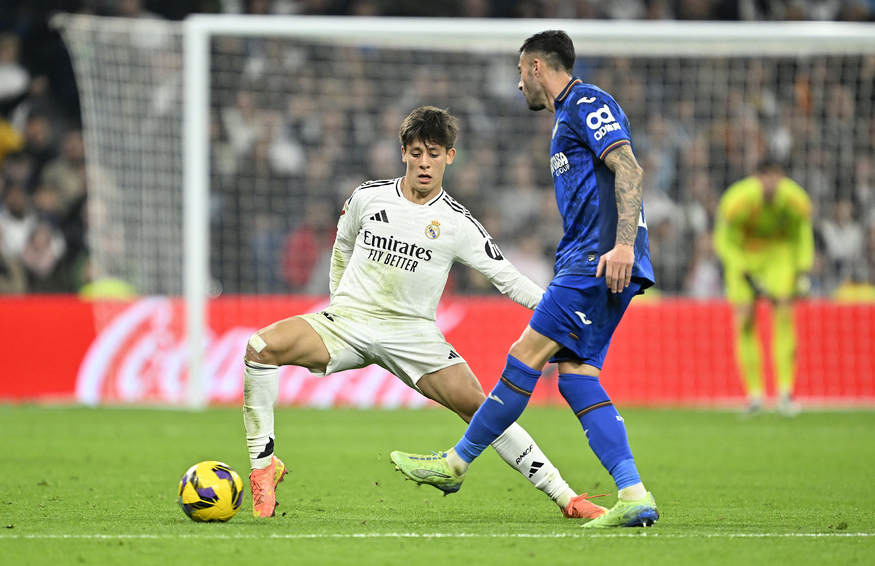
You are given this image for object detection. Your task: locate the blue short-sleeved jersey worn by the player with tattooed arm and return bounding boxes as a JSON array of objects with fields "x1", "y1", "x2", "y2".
[{"x1": 550, "y1": 78, "x2": 654, "y2": 289}]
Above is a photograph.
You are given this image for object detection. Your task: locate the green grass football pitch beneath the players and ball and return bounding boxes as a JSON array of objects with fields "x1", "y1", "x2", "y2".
[{"x1": 0, "y1": 405, "x2": 875, "y2": 566}]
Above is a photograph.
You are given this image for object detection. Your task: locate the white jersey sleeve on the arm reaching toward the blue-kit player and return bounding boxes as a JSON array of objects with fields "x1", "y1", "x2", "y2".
[{"x1": 456, "y1": 213, "x2": 544, "y2": 309}]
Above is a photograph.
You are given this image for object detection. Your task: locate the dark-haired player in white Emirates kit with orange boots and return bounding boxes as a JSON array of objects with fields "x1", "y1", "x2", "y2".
[{"x1": 243, "y1": 106, "x2": 606, "y2": 518}]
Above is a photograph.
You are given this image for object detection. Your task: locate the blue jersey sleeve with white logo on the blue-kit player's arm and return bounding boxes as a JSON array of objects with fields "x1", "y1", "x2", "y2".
[{"x1": 568, "y1": 90, "x2": 632, "y2": 160}]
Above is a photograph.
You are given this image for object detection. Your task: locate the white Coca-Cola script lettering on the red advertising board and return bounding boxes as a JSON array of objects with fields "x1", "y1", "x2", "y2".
[{"x1": 76, "y1": 297, "x2": 465, "y2": 408}]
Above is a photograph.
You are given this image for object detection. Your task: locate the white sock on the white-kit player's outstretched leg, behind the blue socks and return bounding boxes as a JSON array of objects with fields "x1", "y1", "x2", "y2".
[{"x1": 492, "y1": 423, "x2": 577, "y2": 509}]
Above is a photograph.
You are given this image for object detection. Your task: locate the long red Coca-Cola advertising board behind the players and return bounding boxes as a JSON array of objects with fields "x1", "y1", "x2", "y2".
[{"x1": 0, "y1": 296, "x2": 875, "y2": 407}]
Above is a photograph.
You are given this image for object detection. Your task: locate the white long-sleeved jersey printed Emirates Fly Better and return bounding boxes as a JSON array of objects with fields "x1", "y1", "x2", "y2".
[{"x1": 330, "y1": 177, "x2": 544, "y2": 321}]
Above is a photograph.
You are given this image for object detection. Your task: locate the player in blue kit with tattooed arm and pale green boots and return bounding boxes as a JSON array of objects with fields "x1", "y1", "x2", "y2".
[{"x1": 391, "y1": 30, "x2": 659, "y2": 528}]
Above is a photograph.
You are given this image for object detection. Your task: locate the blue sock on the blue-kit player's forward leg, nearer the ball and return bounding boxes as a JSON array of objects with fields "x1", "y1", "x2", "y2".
[{"x1": 456, "y1": 355, "x2": 541, "y2": 464}]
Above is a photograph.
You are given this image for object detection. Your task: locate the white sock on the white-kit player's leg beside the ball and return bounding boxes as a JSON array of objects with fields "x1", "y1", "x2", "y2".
[{"x1": 243, "y1": 360, "x2": 280, "y2": 470}]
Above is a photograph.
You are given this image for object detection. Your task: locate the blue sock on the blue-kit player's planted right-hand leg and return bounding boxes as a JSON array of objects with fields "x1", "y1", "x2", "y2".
[{"x1": 559, "y1": 373, "x2": 641, "y2": 489}]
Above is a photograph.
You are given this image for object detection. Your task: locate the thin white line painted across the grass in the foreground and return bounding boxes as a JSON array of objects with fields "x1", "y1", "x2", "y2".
[{"x1": 0, "y1": 531, "x2": 875, "y2": 540}]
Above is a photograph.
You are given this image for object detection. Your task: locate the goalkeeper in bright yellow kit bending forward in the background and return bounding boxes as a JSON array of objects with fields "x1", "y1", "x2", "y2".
[{"x1": 714, "y1": 160, "x2": 814, "y2": 415}]
